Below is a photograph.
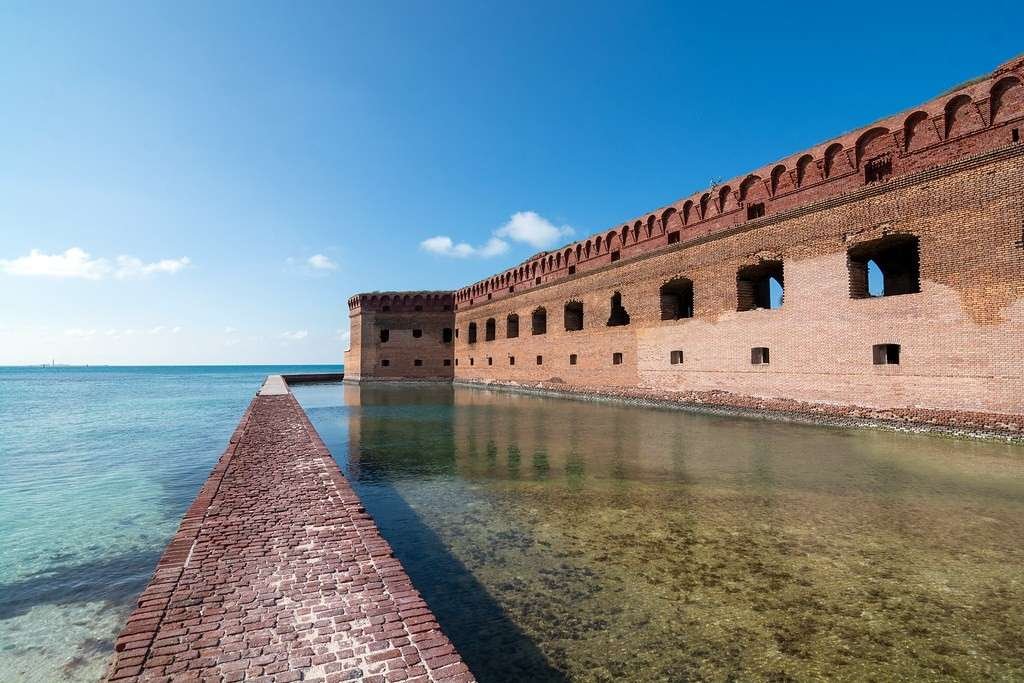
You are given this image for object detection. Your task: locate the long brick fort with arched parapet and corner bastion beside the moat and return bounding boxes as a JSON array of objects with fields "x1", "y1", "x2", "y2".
[{"x1": 345, "y1": 57, "x2": 1024, "y2": 428}]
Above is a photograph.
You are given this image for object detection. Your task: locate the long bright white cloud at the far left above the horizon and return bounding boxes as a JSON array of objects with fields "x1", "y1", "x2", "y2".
[{"x1": 0, "y1": 247, "x2": 191, "y2": 280}]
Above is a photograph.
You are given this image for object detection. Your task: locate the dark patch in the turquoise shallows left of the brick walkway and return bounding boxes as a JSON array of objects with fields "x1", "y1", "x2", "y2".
[{"x1": 0, "y1": 551, "x2": 160, "y2": 620}]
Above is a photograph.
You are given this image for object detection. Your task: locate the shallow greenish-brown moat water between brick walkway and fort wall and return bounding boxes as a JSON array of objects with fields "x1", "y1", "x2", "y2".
[{"x1": 296, "y1": 385, "x2": 1024, "y2": 681}]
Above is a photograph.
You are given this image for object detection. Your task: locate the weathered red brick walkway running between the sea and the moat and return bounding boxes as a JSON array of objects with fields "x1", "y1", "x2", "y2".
[{"x1": 108, "y1": 394, "x2": 473, "y2": 683}]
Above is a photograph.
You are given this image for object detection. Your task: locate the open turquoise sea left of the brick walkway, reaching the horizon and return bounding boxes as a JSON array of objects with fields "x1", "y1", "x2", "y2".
[{"x1": 0, "y1": 366, "x2": 341, "y2": 683}]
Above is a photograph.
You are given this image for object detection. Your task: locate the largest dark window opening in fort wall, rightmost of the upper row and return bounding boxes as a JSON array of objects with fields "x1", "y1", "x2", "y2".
[{"x1": 847, "y1": 234, "x2": 921, "y2": 299}]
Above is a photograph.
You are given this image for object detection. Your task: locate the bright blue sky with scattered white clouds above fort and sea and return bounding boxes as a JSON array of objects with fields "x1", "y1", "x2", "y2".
[{"x1": 0, "y1": 2, "x2": 1024, "y2": 365}]
